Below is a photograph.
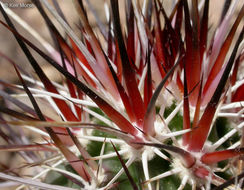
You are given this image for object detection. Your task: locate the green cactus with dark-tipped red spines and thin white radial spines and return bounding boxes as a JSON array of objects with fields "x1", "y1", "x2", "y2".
[{"x1": 0, "y1": 0, "x2": 244, "y2": 190}]
